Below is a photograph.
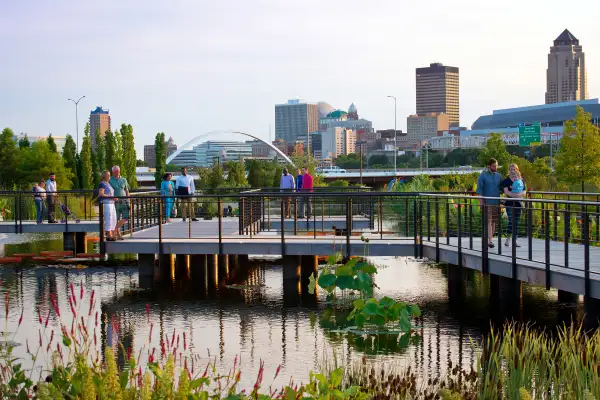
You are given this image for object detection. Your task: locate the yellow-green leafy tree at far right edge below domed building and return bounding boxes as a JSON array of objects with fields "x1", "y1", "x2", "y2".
[{"x1": 556, "y1": 106, "x2": 600, "y2": 191}]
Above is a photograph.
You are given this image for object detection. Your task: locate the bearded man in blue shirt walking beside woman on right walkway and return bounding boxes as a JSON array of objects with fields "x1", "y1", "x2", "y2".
[{"x1": 477, "y1": 158, "x2": 502, "y2": 248}]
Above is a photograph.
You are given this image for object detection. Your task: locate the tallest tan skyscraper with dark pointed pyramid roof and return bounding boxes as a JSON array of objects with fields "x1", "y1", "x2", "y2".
[{"x1": 546, "y1": 29, "x2": 588, "y2": 104}]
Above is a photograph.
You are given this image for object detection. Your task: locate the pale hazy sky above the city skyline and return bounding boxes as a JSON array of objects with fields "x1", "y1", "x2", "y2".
[{"x1": 0, "y1": 0, "x2": 600, "y2": 158}]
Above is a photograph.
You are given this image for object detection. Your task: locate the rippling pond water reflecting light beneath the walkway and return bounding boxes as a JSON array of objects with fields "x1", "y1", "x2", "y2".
[{"x1": 0, "y1": 235, "x2": 583, "y2": 385}]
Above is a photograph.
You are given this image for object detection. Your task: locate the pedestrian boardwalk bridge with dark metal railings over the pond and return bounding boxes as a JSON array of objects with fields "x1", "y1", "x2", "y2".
[{"x1": 1, "y1": 188, "x2": 600, "y2": 299}]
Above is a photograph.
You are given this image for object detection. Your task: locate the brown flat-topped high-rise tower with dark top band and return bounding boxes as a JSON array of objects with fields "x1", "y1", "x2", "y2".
[{"x1": 417, "y1": 63, "x2": 460, "y2": 126}]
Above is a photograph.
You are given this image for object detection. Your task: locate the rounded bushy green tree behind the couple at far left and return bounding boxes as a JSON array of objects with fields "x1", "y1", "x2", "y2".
[{"x1": 18, "y1": 140, "x2": 74, "y2": 190}]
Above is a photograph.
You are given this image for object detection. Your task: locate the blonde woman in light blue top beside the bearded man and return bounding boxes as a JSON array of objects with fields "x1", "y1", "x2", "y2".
[{"x1": 501, "y1": 164, "x2": 526, "y2": 247}]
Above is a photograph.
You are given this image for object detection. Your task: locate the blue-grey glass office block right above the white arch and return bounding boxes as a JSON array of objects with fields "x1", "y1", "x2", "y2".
[{"x1": 275, "y1": 100, "x2": 319, "y2": 147}]
